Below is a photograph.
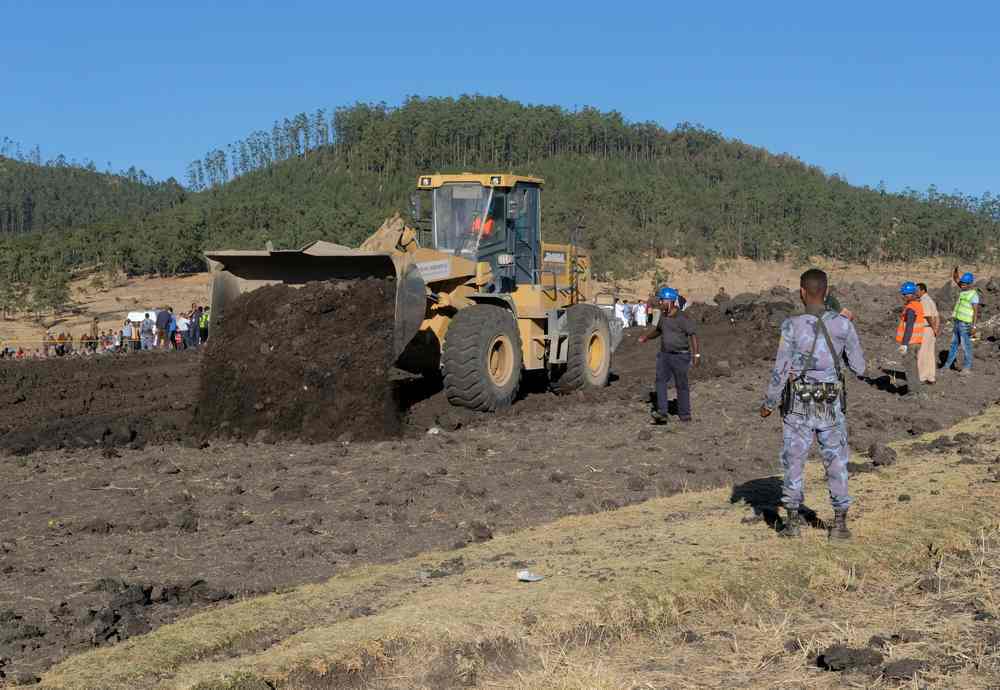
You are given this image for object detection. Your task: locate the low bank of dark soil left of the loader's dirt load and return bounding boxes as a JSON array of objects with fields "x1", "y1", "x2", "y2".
[{"x1": 0, "y1": 352, "x2": 198, "y2": 455}]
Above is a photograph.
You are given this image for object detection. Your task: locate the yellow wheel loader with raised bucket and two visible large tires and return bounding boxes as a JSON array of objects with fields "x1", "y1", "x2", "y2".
[{"x1": 206, "y1": 173, "x2": 622, "y2": 411}]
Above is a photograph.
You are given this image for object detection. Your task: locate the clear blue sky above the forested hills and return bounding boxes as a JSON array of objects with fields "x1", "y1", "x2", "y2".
[{"x1": 0, "y1": 0, "x2": 1000, "y2": 195}]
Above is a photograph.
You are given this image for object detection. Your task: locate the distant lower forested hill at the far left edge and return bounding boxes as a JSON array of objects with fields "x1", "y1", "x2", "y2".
[{"x1": 0, "y1": 155, "x2": 186, "y2": 237}]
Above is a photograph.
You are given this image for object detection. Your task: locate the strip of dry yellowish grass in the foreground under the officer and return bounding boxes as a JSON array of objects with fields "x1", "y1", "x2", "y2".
[{"x1": 37, "y1": 408, "x2": 1000, "y2": 690}]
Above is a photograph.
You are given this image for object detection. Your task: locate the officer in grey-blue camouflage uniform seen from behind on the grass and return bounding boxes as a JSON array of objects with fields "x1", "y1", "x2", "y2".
[{"x1": 760, "y1": 268, "x2": 865, "y2": 539}]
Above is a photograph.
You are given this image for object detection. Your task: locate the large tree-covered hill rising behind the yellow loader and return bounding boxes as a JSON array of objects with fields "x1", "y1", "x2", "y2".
[{"x1": 0, "y1": 96, "x2": 1000, "y2": 314}]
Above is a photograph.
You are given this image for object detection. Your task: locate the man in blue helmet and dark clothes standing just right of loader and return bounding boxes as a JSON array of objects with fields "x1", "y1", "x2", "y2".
[{"x1": 639, "y1": 287, "x2": 701, "y2": 424}]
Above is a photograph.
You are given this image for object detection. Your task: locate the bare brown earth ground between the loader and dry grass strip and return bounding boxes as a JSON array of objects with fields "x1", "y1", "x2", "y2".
[{"x1": 0, "y1": 272, "x2": 1000, "y2": 678}]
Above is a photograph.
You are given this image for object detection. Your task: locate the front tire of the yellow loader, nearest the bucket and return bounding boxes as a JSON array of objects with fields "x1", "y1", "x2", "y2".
[{"x1": 441, "y1": 304, "x2": 522, "y2": 412}]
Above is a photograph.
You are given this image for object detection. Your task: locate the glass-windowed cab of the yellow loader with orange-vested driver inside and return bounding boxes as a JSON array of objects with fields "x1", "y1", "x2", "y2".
[{"x1": 414, "y1": 174, "x2": 542, "y2": 292}]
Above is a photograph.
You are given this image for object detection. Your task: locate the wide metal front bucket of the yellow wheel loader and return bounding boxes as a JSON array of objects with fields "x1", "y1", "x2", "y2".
[{"x1": 205, "y1": 242, "x2": 427, "y2": 359}]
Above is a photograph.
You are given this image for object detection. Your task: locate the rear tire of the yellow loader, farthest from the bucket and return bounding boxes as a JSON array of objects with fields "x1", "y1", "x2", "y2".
[{"x1": 552, "y1": 304, "x2": 611, "y2": 393}]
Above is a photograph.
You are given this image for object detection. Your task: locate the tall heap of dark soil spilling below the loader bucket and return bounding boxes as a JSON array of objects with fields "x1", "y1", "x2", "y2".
[{"x1": 194, "y1": 279, "x2": 401, "y2": 442}]
